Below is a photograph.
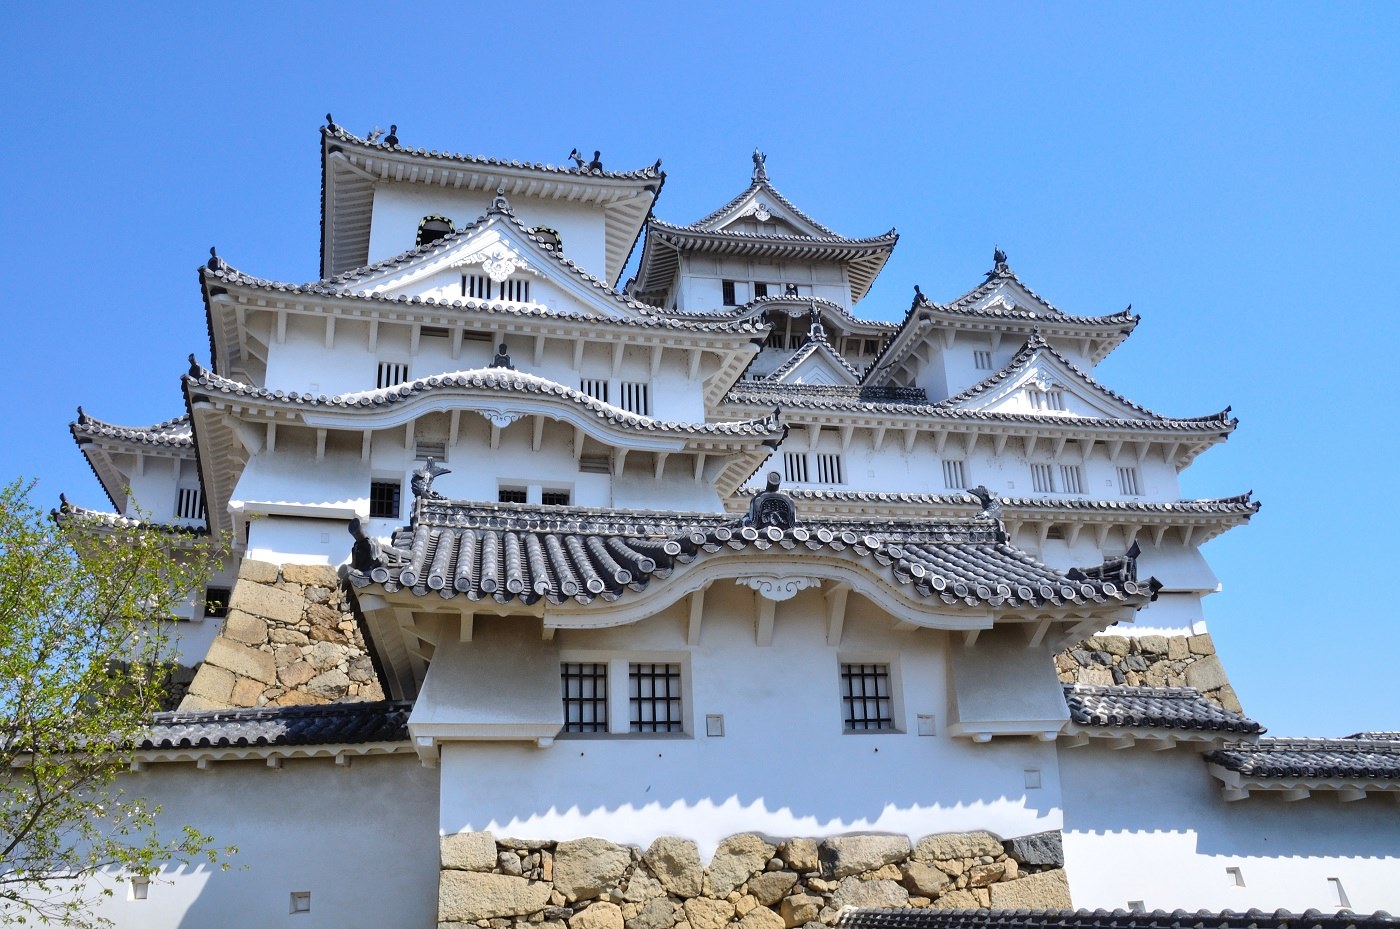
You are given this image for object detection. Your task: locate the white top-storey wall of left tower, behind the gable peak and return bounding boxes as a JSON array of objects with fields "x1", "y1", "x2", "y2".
[{"x1": 370, "y1": 183, "x2": 612, "y2": 277}]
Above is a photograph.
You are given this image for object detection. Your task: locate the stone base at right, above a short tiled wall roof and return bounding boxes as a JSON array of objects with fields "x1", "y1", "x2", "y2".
[{"x1": 1054, "y1": 632, "x2": 1243, "y2": 712}]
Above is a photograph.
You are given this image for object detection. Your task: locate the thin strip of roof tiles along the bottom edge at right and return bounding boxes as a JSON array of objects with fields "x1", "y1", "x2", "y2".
[{"x1": 836, "y1": 909, "x2": 1400, "y2": 929}]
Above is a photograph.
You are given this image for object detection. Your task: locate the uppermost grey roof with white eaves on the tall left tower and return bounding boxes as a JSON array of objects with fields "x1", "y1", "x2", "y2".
[{"x1": 321, "y1": 120, "x2": 666, "y2": 281}]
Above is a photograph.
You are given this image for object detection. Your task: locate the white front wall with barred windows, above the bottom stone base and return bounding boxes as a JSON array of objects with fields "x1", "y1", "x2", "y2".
[{"x1": 441, "y1": 583, "x2": 1060, "y2": 856}]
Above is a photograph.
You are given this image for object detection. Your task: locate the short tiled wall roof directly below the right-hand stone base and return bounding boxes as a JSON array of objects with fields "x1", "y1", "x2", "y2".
[{"x1": 1064, "y1": 684, "x2": 1264, "y2": 733}]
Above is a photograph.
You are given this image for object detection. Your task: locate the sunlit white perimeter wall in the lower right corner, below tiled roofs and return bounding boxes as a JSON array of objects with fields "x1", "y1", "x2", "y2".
[{"x1": 1060, "y1": 747, "x2": 1400, "y2": 912}]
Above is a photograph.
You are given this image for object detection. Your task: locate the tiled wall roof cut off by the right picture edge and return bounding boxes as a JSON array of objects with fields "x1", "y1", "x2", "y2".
[{"x1": 1205, "y1": 733, "x2": 1400, "y2": 781}]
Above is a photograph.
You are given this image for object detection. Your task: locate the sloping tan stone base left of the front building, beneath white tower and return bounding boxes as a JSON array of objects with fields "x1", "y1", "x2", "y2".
[{"x1": 179, "y1": 561, "x2": 384, "y2": 709}]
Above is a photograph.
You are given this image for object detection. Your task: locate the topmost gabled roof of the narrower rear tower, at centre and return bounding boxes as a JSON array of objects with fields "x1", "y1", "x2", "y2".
[{"x1": 631, "y1": 153, "x2": 899, "y2": 304}]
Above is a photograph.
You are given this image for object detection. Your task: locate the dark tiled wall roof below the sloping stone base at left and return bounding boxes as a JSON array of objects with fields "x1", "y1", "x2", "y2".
[{"x1": 136, "y1": 701, "x2": 413, "y2": 751}]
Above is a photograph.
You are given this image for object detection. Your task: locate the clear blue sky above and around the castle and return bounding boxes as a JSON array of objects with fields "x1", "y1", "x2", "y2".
[{"x1": 0, "y1": 3, "x2": 1400, "y2": 735}]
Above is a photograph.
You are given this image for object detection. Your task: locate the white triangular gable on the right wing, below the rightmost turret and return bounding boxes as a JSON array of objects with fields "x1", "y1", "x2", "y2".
[{"x1": 938, "y1": 333, "x2": 1163, "y2": 420}]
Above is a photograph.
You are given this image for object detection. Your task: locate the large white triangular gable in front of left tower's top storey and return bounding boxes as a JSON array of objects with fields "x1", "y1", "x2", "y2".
[{"x1": 328, "y1": 197, "x2": 643, "y2": 318}]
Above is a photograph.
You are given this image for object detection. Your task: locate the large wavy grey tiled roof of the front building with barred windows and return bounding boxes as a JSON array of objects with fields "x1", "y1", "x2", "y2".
[{"x1": 350, "y1": 504, "x2": 1149, "y2": 607}]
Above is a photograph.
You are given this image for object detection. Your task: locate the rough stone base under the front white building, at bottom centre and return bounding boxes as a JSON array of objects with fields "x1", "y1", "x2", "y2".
[{"x1": 438, "y1": 832, "x2": 1071, "y2": 929}]
